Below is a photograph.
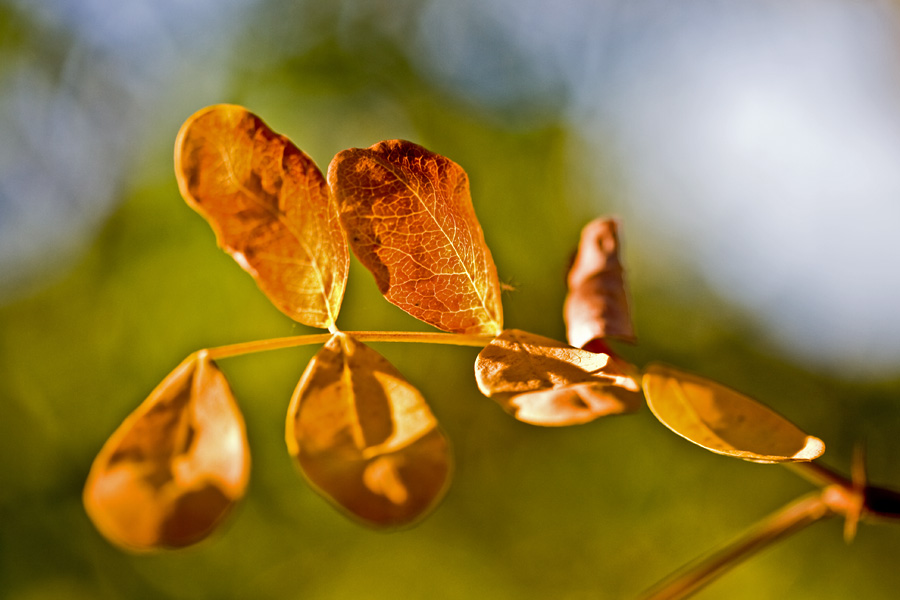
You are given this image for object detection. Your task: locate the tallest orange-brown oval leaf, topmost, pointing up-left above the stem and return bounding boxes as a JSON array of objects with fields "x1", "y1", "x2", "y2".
[{"x1": 175, "y1": 105, "x2": 350, "y2": 329}]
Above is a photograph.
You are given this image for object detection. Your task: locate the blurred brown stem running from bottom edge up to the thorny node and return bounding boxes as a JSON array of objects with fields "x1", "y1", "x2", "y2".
[{"x1": 642, "y1": 490, "x2": 834, "y2": 600}]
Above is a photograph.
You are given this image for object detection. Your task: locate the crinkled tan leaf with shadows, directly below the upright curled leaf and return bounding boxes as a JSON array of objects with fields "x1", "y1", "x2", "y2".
[{"x1": 475, "y1": 329, "x2": 641, "y2": 426}]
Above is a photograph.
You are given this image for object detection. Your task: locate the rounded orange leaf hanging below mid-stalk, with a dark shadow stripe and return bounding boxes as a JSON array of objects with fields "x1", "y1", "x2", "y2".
[{"x1": 285, "y1": 333, "x2": 451, "y2": 527}]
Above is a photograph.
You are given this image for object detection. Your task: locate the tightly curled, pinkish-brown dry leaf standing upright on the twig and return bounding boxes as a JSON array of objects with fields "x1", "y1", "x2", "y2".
[{"x1": 563, "y1": 219, "x2": 635, "y2": 349}]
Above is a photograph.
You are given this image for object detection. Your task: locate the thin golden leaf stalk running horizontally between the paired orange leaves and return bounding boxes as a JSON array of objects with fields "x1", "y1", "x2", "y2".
[{"x1": 206, "y1": 331, "x2": 494, "y2": 360}]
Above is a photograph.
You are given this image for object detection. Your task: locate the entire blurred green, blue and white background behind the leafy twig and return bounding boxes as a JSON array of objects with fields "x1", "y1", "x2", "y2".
[{"x1": 0, "y1": 0, "x2": 900, "y2": 600}]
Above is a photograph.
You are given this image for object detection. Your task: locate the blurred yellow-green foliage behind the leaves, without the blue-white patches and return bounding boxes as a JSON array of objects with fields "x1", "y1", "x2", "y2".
[{"x1": 0, "y1": 2, "x2": 900, "y2": 600}]
